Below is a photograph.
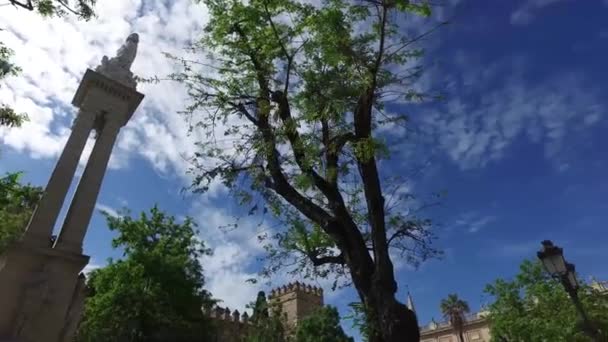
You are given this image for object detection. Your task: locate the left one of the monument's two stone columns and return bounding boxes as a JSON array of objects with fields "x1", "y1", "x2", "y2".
[{"x1": 24, "y1": 109, "x2": 95, "y2": 246}]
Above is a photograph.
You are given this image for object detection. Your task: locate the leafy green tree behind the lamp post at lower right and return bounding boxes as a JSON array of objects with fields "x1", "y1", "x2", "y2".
[{"x1": 485, "y1": 260, "x2": 608, "y2": 342}]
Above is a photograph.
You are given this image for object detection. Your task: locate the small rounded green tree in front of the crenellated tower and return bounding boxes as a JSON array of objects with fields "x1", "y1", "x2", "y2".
[{"x1": 295, "y1": 306, "x2": 354, "y2": 342}]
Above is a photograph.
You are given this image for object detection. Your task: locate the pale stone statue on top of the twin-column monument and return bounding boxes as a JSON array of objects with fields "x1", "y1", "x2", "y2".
[{"x1": 95, "y1": 33, "x2": 139, "y2": 88}]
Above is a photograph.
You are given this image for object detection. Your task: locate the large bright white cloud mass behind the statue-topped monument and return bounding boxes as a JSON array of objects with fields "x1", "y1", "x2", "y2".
[{"x1": 0, "y1": 0, "x2": 207, "y2": 180}]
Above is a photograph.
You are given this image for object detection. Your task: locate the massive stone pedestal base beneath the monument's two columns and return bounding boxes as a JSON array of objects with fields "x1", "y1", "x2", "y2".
[{"x1": 0, "y1": 242, "x2": 89, "y2": 342}]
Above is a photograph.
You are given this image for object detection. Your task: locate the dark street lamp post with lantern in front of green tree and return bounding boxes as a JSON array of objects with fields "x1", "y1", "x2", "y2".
[{"x1": 536, "y1": 240, "x2": 600, "y2": 342}]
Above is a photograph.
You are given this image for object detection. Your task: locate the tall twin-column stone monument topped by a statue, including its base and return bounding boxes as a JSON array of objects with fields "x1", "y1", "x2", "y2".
[{"x1": 0, "y1": 34, "x2": 144, "y2": 342}]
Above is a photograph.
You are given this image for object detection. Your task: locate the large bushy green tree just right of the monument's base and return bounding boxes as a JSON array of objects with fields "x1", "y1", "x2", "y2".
[{"x1": 78, "y1": 206, "x2": 212, "y2": 341}]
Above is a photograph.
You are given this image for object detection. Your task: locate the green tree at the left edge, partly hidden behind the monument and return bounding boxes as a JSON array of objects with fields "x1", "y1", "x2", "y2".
[{"x1": 0, "y1": 173, "x2": 42, "y2": 254}]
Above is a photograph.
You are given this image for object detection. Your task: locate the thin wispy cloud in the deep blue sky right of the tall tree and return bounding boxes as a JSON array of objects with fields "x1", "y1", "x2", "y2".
[{"x1": 417, "y1": 56, "x2": 606, "y2": 170}]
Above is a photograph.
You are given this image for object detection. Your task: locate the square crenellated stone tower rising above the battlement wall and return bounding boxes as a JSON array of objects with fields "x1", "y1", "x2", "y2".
[{"x1": 268, "y1": 281, "x2": 323, "y2": 330}]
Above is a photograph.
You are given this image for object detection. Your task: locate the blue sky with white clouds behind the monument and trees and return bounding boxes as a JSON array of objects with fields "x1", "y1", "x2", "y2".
[{"x1": 0, "y1": 0, "x2": 608, "y2": 338}]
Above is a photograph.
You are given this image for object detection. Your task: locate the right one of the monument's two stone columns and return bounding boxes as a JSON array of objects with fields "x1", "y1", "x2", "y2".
[{"x1": 54, "y1": 113, "x2": 122, "y2": 253}]
